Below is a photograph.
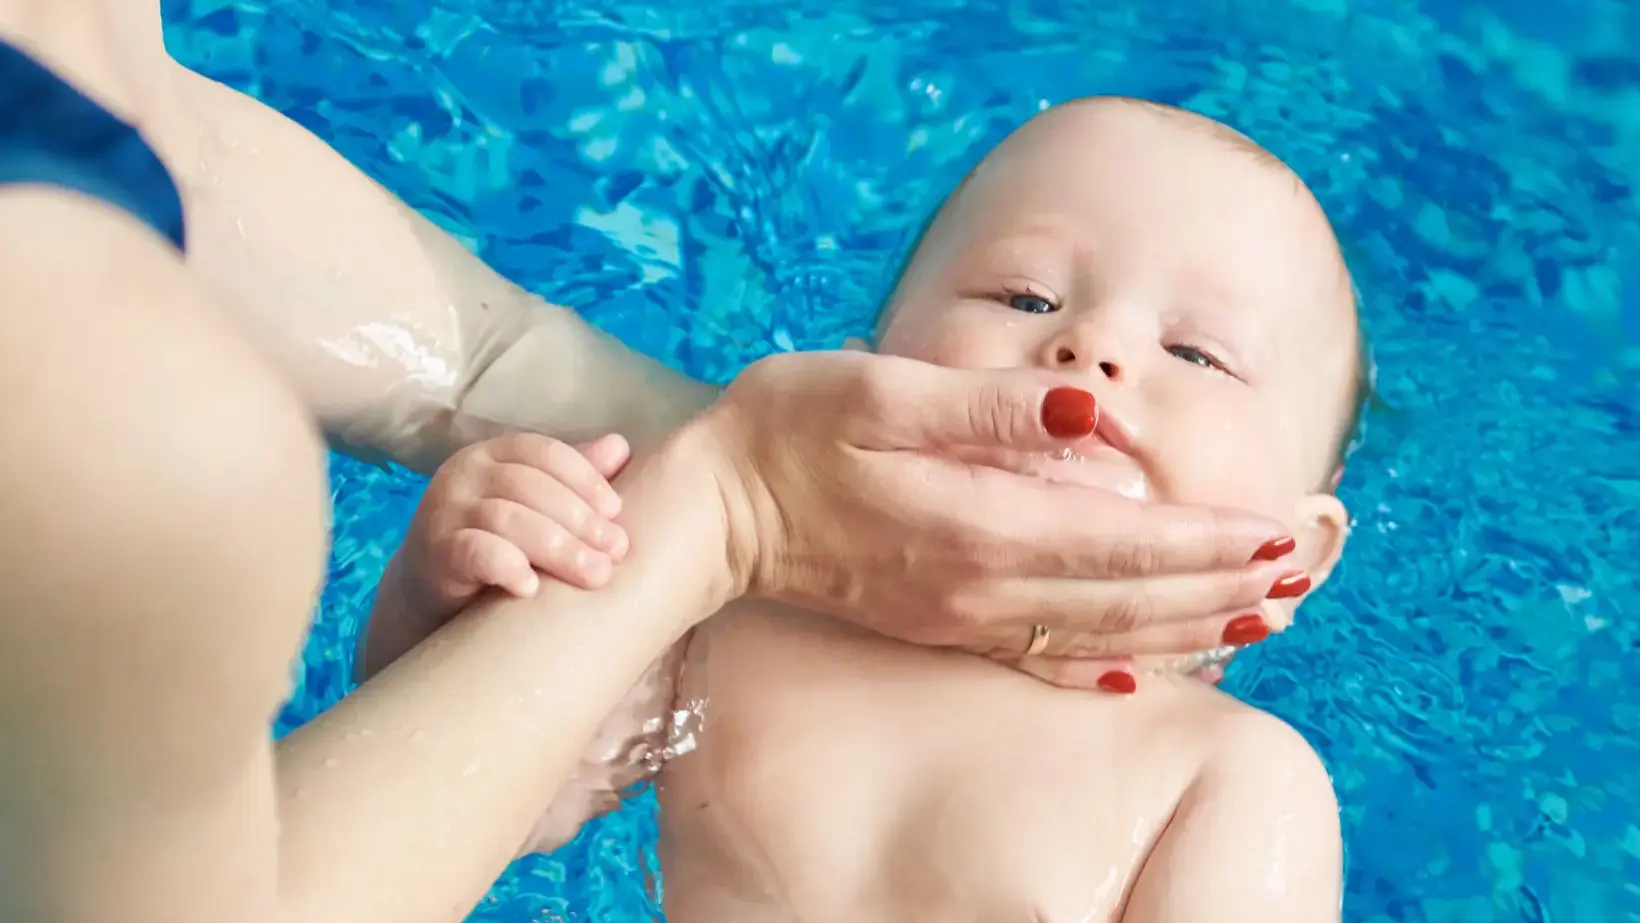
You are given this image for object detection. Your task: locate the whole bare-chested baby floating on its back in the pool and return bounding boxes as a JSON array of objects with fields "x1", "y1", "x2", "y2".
[{"x1": 364, "y1": 98, "x2": 1361, "y2": 923}]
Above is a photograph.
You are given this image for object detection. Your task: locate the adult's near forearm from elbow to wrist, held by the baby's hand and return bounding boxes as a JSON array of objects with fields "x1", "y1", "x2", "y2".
[{"x1": 279, "y1": 432, "x2": 730, "y2": 923}]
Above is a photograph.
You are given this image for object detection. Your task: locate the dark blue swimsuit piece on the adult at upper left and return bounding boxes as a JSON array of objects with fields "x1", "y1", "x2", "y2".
[{"x1": 0, "y1": 41, "x2": 184, "y2": 251}]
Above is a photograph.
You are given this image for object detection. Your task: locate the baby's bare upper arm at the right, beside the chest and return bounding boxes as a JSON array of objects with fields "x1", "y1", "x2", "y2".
[{"x1": 1122, "y1": 713, "x2": 1343, "y2": 923}]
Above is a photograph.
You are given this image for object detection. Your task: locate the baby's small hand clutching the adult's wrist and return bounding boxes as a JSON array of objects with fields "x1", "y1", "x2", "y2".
[{"x1": 402, "y1": 433, "x2": 631, "y2": 616}]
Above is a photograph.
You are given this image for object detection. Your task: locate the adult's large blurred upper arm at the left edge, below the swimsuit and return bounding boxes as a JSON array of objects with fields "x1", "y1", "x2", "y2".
[{"x1": 0, "y1": 187, "x2": 326, "y2": 923}]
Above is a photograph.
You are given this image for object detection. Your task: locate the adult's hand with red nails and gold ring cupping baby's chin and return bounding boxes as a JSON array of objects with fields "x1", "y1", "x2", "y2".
[{"x1": 690, "y1": 351, "x2": 1287, "y2": 687}]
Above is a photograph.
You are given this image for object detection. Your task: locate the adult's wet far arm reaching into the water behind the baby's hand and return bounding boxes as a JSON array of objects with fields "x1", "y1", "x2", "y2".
[{"x1": 144, "y1": 59, "x2": 715, "y2": 472}]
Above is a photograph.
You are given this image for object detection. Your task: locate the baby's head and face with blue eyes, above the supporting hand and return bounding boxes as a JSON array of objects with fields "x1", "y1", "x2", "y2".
[{"x1": 877, "y1": 98, "x2": 1364, "y2": 596}]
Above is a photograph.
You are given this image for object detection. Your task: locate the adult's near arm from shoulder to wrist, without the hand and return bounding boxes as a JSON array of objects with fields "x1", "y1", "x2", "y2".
[{"x1": 0, "y1": 189, "x2": 728, "y2": 923}]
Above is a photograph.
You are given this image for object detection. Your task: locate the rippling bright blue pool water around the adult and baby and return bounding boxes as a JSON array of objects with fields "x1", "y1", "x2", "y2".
[{"x1": 167, "y1": 0, "x2": 1640, "y2": 923}]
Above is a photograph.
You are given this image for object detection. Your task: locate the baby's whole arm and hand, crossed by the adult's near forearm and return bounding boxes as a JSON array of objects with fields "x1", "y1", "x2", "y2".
[{"x1": 356, "y1": 433, "x2": 687, "y2": 853}]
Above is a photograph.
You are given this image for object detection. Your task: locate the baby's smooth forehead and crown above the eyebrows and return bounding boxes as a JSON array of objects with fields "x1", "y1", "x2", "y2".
[{"x1": 951, "y1": 98, "x2": 1346, "y2": 280}]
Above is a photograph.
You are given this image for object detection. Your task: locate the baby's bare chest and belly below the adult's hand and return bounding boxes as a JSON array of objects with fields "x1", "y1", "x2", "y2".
[{"x1": 661, "y1": 607, "x2": 1220, "y2": 923}]
